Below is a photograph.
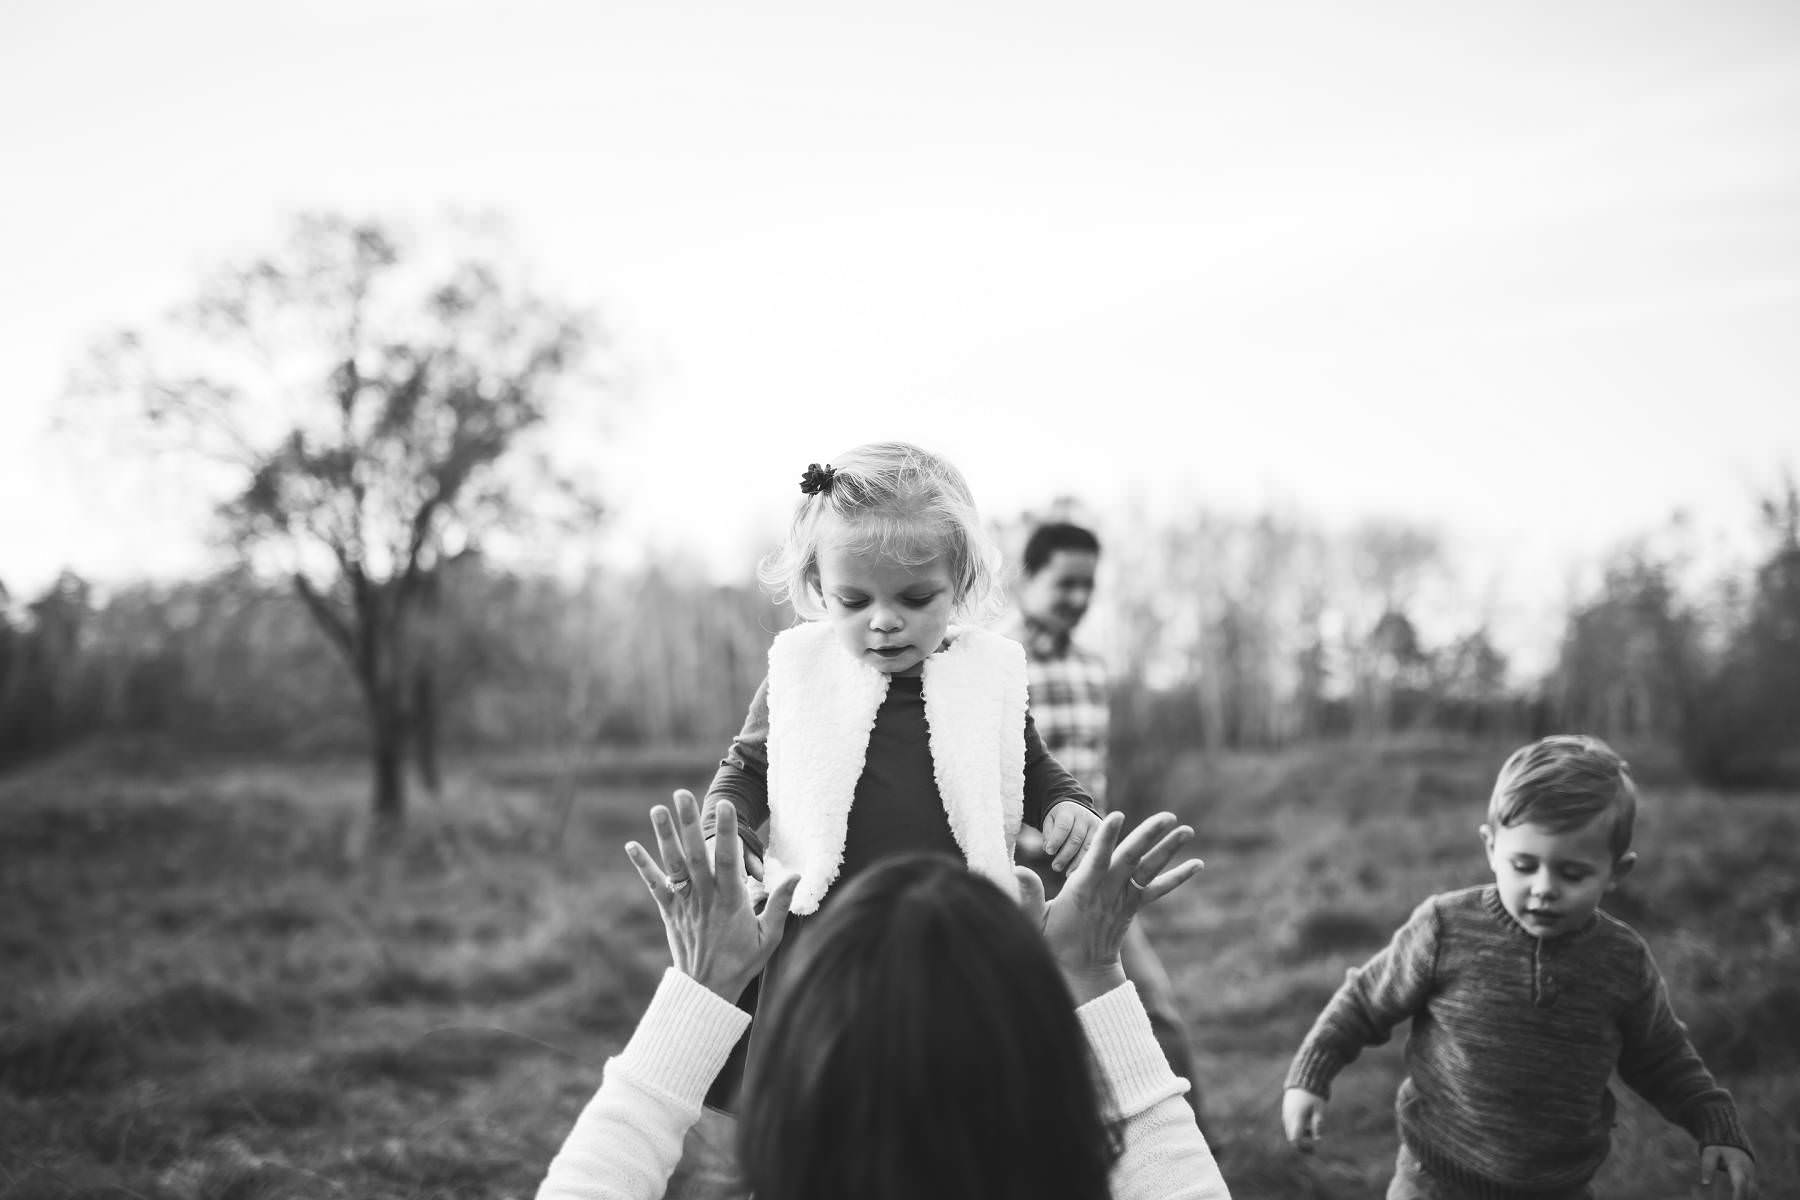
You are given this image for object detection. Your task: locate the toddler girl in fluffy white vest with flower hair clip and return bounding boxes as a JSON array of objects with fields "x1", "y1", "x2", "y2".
[{"x1": 706, "y1": 443, "x2": 1100, "y2": 1105}]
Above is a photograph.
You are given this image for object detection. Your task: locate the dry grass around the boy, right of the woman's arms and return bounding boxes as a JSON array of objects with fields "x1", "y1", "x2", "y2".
[{"x1": 1150, "y1": 741, "x2": 1800, "y2": 1200}]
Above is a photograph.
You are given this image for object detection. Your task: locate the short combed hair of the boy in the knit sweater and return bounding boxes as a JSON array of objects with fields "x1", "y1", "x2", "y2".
[{"x1": 1487, "y1": 734, "x2": 1638, "y2": 858}]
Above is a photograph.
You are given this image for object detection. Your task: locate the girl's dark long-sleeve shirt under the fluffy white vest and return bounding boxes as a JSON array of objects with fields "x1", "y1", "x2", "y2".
[{"x1": 706, "y1": 676, "x2": 1098, "y2": 885}]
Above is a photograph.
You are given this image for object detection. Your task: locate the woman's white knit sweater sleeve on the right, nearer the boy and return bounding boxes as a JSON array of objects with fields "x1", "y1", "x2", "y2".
[{"x1": 1076, "y1": 982, "x2": 1231, "y2": 1200}]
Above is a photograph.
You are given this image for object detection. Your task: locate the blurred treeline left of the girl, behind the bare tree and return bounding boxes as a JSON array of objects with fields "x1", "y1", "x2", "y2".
[{"x1": 0, "y1": 556, "x2": 785, "y2": 759}]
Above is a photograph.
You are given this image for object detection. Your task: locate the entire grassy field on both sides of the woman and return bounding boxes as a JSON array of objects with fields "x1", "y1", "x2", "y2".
[{"x1": 0, "y1": 743, "x2": 1800, "y2": 1200}]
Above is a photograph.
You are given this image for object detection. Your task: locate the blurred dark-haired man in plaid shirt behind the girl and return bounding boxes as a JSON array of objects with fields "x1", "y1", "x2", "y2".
[{"x1": 1006, "y1": 522, "x2": 1217, "y2": 1150}]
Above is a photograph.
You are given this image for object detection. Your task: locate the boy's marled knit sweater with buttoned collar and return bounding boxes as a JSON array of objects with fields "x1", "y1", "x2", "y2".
[{"x1": 1287, "y1": 885, "x2": 1750, "y2": 1200}]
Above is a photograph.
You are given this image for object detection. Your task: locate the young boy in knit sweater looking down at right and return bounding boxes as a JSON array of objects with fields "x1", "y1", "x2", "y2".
[{"x1": 1282, "y1": 736, "x2": 1757, "y2": 1200}]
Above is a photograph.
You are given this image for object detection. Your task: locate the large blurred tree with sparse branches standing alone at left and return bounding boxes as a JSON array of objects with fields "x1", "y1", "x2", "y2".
[{"x1": 70, "y1": 214, "x2": 612, "y2": 840}]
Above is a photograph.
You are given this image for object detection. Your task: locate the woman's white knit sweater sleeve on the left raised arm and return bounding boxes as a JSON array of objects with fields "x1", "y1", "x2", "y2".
[{"x1": 538, "y1": 968, "x2": 751, "y2": 1200}]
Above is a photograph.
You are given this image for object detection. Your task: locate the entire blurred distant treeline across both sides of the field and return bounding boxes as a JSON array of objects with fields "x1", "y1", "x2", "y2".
[{"x1": 0, "y1": 482, "x2": 1800, "y2": 788}]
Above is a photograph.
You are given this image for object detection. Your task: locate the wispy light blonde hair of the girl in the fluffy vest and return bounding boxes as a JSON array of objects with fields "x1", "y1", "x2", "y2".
[{"x1": 758, "y1": 441, "x2": 1004, "y2": 621}]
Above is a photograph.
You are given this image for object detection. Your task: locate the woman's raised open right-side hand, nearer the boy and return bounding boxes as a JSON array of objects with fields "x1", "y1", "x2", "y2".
[{"x1": 1013, "y1": 811, "x2": 1204, "y2": 1004}]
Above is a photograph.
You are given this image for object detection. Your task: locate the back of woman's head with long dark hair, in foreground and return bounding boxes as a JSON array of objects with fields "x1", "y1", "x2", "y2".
[{"x1": 740, "y1": 855, "x2": 1118, "y2": 1200}]
